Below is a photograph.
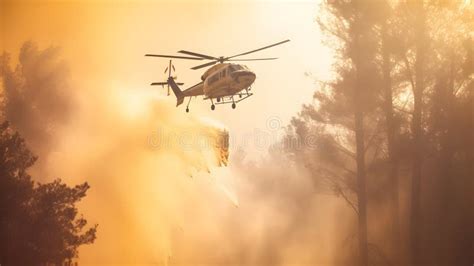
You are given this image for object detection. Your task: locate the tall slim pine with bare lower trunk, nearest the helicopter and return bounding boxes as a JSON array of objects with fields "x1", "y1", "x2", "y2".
[{"x1": 314, "y1": 0, "x2": 388, "y2": 265}]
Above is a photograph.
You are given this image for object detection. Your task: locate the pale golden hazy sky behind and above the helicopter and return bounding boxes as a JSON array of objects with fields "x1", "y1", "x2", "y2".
[{"x1": 0, "y1": 0, "x2": 331, "y2": 158}]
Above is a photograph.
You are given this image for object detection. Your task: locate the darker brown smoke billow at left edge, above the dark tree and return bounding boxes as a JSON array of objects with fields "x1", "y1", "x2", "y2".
[{"x1": 0, "y1": 42, "x2": 74, "y2": 158}]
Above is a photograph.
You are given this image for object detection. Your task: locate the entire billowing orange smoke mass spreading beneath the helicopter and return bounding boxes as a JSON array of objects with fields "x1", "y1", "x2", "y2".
[{"x1": 3, "y1": 44, "x2": 355, "y2": 265}]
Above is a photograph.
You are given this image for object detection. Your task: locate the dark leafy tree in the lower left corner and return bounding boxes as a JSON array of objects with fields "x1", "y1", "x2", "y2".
[{"x1": 0, "y1": 122, "x2": 97, "y2": 265}]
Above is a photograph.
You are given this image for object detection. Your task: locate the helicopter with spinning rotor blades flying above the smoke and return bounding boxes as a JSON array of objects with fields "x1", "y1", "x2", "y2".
[{"x1": 145, "y1": 40, "x2": 290, "y2": 112}]
